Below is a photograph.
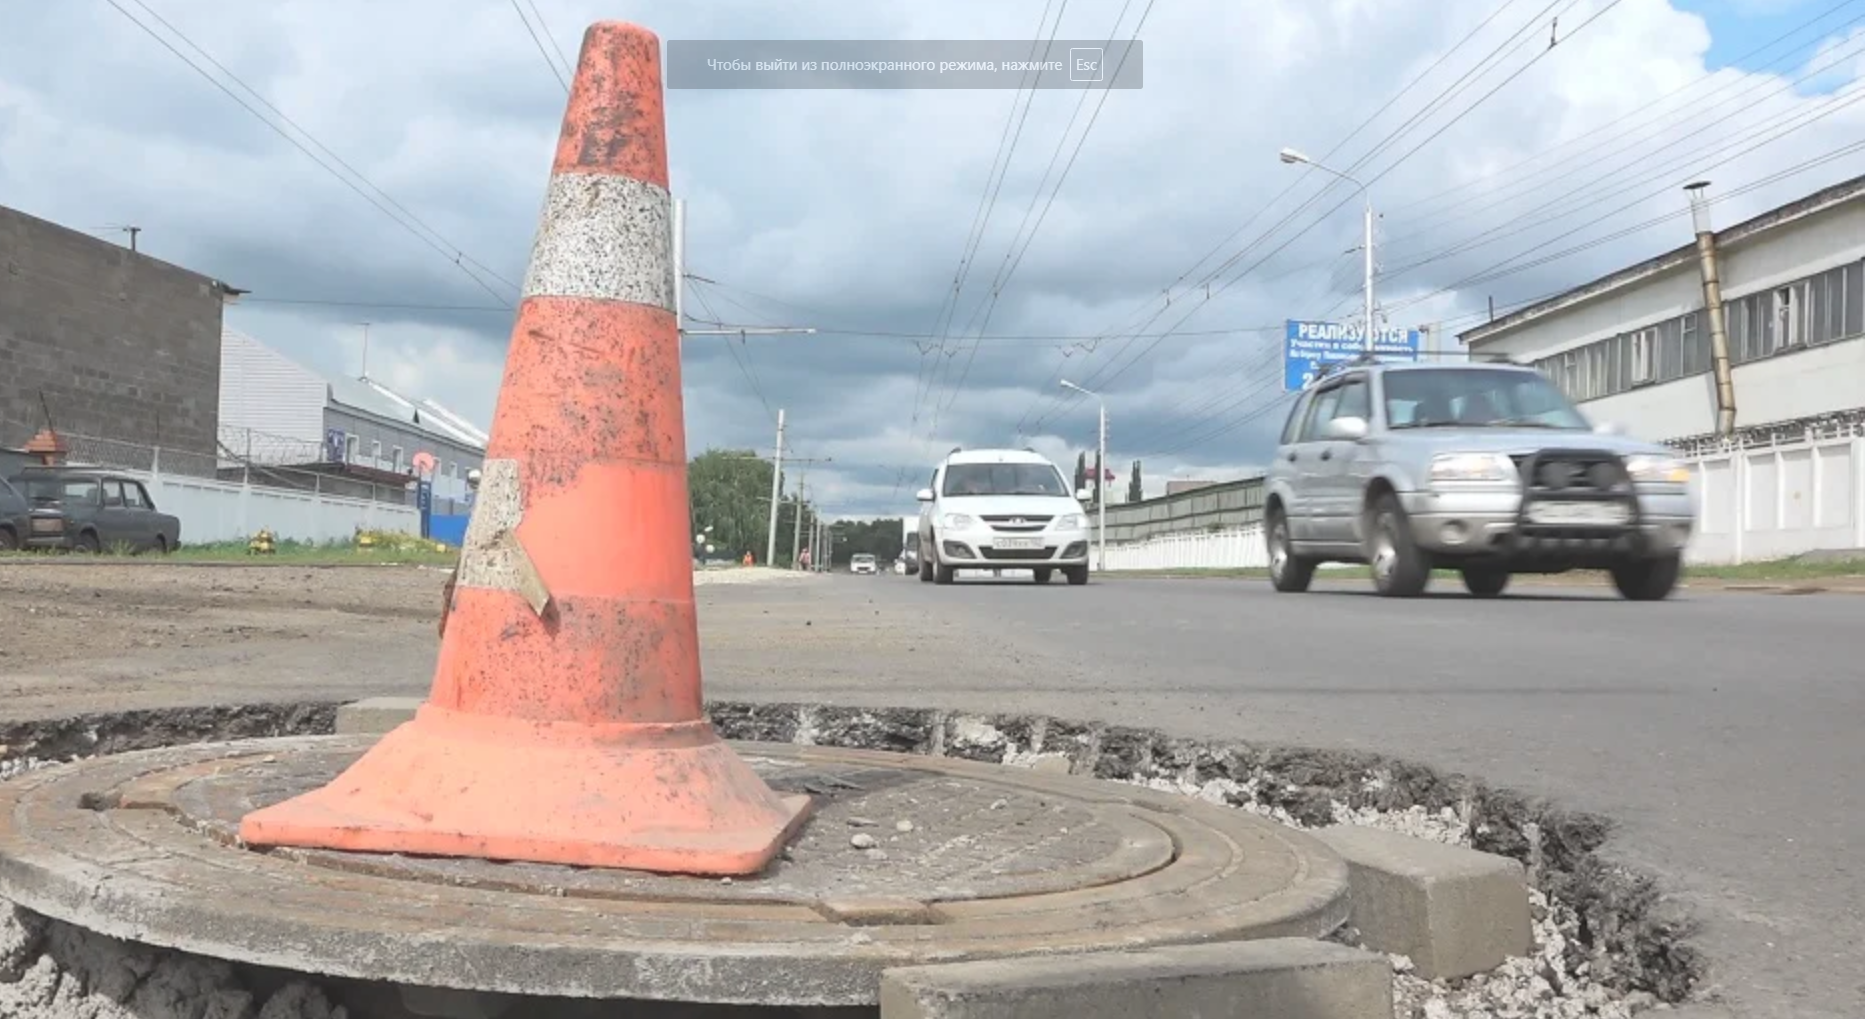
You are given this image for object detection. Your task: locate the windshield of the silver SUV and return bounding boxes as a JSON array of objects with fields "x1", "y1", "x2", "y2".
[{"x1": 1382, "y1": 368, "x2": 1589, "y2": 429}]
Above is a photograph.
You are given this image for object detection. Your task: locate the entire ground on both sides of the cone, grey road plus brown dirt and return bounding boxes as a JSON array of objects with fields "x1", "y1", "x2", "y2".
[{"x1": 0, "y1": 567, "x2": 1865, "y2": 1019}]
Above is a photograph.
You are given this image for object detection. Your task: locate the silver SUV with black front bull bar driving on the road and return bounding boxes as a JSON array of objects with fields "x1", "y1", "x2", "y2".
[{"x1": 1263, "y1": 358, "x2": 1695, "y2": 601}]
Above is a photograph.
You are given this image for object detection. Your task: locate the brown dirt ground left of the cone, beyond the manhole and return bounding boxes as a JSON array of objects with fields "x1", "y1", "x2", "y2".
[{"x1": 0, "y1": 562, "x2": 446, "y2": 719}]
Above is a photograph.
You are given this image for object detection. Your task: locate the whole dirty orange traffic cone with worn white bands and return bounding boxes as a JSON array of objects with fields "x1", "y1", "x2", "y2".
[{"x1": 241, "y1": 22, "x2": 809, "y2": 875}]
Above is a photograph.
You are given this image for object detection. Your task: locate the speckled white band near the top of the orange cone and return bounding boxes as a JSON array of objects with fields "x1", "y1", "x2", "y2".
[{"x1": 524, "y1": 174, "x2": 673, "y2": 312}]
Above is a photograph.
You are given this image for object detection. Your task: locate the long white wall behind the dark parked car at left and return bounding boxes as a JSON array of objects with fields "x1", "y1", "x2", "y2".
[{"x1": 141, "y1": 470, "x2": 421, "y2": 545}]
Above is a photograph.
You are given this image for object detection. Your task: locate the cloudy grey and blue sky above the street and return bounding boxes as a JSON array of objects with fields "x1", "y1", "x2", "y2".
[{"x1": 0, "y1": 0, "x2": 1865, "y2": 515}]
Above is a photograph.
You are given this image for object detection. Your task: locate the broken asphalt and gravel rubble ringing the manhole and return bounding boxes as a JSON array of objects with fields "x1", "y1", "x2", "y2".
[{"x1": 0, "y1": 697, "x2": 1699, "y2": 1019}]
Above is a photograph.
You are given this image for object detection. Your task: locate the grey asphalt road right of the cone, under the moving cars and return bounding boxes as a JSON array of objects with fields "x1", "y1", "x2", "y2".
[{"x1": 701, "y1": 577, "x2": 1865, "y2": 1019}]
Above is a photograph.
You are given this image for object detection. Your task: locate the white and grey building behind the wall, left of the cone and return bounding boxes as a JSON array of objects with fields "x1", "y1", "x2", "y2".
[{"x1": 220, "y1": 328, "x2": 487, "y2": 513}]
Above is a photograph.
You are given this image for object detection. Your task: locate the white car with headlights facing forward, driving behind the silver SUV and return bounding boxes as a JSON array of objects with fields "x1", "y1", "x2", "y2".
[{"x1": 918, "y1": 450, "x2": 1087, "y2": 584}]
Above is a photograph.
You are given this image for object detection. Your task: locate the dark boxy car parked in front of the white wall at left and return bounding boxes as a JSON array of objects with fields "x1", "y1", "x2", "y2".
[{"x1": 13, "y1": 467, "x2": 181, "y2": 552}]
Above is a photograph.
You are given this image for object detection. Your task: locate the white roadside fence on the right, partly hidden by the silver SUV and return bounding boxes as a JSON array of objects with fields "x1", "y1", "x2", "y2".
[{"x1": 1108, "y1": 437, "x2": 1865, "y2": 573}]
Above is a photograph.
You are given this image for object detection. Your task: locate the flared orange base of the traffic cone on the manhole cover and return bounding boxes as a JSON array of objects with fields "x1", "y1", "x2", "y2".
[{"x1": 239, "y1": 705, "x2": 811, "y2": 877}]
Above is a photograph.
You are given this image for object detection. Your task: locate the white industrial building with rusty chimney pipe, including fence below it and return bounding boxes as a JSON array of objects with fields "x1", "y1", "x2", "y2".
[{"x1": 1458, "y1": 170, "x2": 1865, "y2": 562}]
